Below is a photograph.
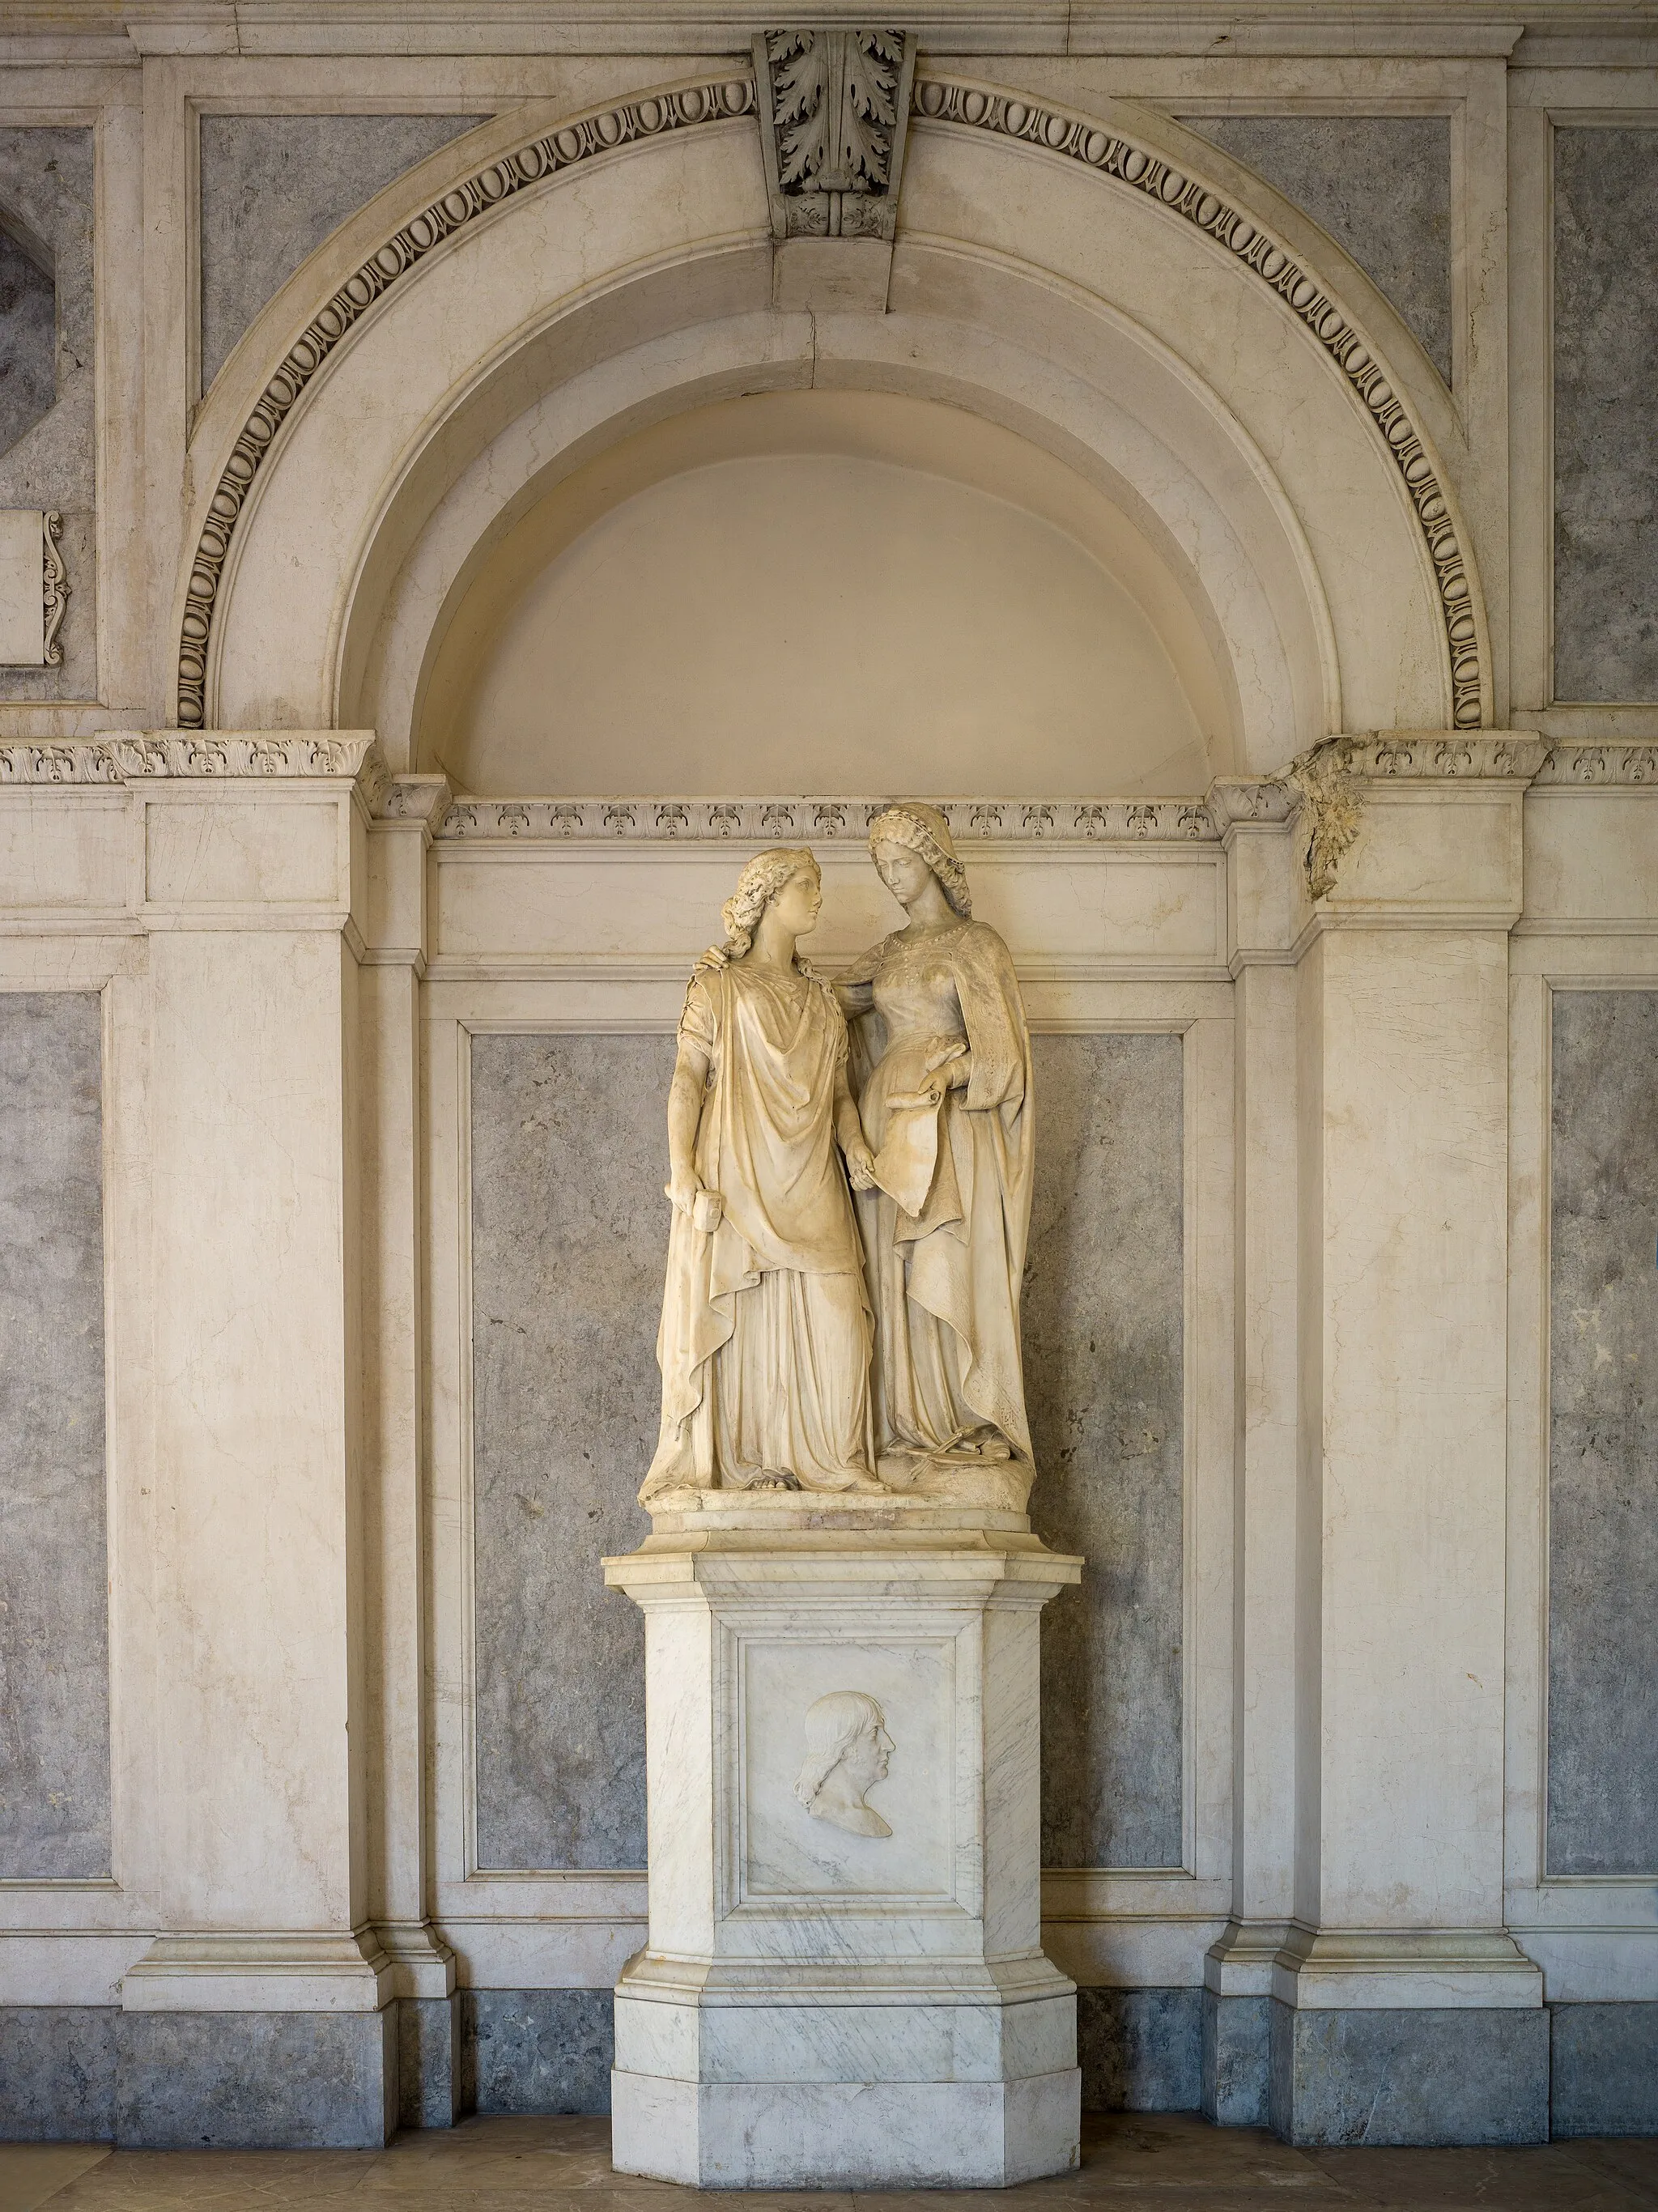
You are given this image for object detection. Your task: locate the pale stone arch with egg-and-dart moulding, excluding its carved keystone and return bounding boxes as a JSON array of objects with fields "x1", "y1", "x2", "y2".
[{"x1": 176, "y1": 75, "x2": 1490, "y2": 770}]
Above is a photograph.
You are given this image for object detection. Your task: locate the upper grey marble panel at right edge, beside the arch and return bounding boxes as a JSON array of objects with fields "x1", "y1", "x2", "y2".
[{"x1": 1554, "y1": 128, "x2": 1658, "y2": 699}]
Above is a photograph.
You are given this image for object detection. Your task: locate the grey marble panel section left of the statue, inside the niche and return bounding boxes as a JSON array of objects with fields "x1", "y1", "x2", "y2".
[{"x1": 471, "y1": 1036, "x2": 674, "y2": 1867}]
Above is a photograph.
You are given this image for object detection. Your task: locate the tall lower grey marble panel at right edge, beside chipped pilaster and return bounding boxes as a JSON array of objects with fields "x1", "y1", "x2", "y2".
[{"x1": 1547, "y1": 991, "x2": 1658, "y2": 1878}]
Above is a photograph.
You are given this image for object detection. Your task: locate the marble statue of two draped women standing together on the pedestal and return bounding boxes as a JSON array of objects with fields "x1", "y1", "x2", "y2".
[{"x1": 639, "y1": 803, "x2": 1032, "y2": 1511}]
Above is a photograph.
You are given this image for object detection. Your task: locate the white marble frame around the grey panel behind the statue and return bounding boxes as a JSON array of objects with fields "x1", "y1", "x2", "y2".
[{"x1": 423, "y1": 964, "x2": 1234, "y2": 1989}]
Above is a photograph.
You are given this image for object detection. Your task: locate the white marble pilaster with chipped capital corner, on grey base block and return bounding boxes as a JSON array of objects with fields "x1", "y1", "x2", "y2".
[{"x1": 1269, "y1": 732, "x2": 1547, "y2": 2143}]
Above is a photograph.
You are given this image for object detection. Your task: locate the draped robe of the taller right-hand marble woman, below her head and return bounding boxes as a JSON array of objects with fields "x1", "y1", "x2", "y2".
[{"x1": 842, "y1": 922, "x2": 1032, "y2": 1465}]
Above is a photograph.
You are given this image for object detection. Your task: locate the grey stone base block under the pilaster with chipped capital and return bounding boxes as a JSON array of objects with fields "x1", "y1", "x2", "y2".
[{"x1": 1269, "y1": 1997, "x2": 1550, "y2": 2146}]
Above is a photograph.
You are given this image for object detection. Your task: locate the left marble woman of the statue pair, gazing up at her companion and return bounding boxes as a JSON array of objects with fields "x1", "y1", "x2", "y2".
[{"x1": 639, "y1": 847, "x2": 882, "y2": 1504}]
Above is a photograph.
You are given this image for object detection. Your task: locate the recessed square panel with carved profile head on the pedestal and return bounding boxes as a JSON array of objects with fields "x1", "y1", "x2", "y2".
[{"x1": 741, "y1": 1637, "x2": 955, "y2": 1903}]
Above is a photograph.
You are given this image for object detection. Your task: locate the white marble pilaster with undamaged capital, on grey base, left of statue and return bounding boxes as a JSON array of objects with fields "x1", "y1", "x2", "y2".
[{"x1": 35, "y1": 732, "x2": 396, "y2": 2146}]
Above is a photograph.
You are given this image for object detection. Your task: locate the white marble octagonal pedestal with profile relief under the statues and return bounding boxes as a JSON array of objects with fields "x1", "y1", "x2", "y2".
[{"x1": 606, "y1": 1493, "x2": 1081, "y2": 2190}]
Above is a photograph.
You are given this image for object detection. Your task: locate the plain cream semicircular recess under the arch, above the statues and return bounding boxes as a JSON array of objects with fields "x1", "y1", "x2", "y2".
[{"x1": 418, "y1": 392, "x2": 1235, "y2": 798}]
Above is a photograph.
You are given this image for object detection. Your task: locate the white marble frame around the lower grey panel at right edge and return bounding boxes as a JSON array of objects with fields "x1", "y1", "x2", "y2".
[{"x1": 1503, "y1": 927, "x2": 1658, "y2": 2004}]
